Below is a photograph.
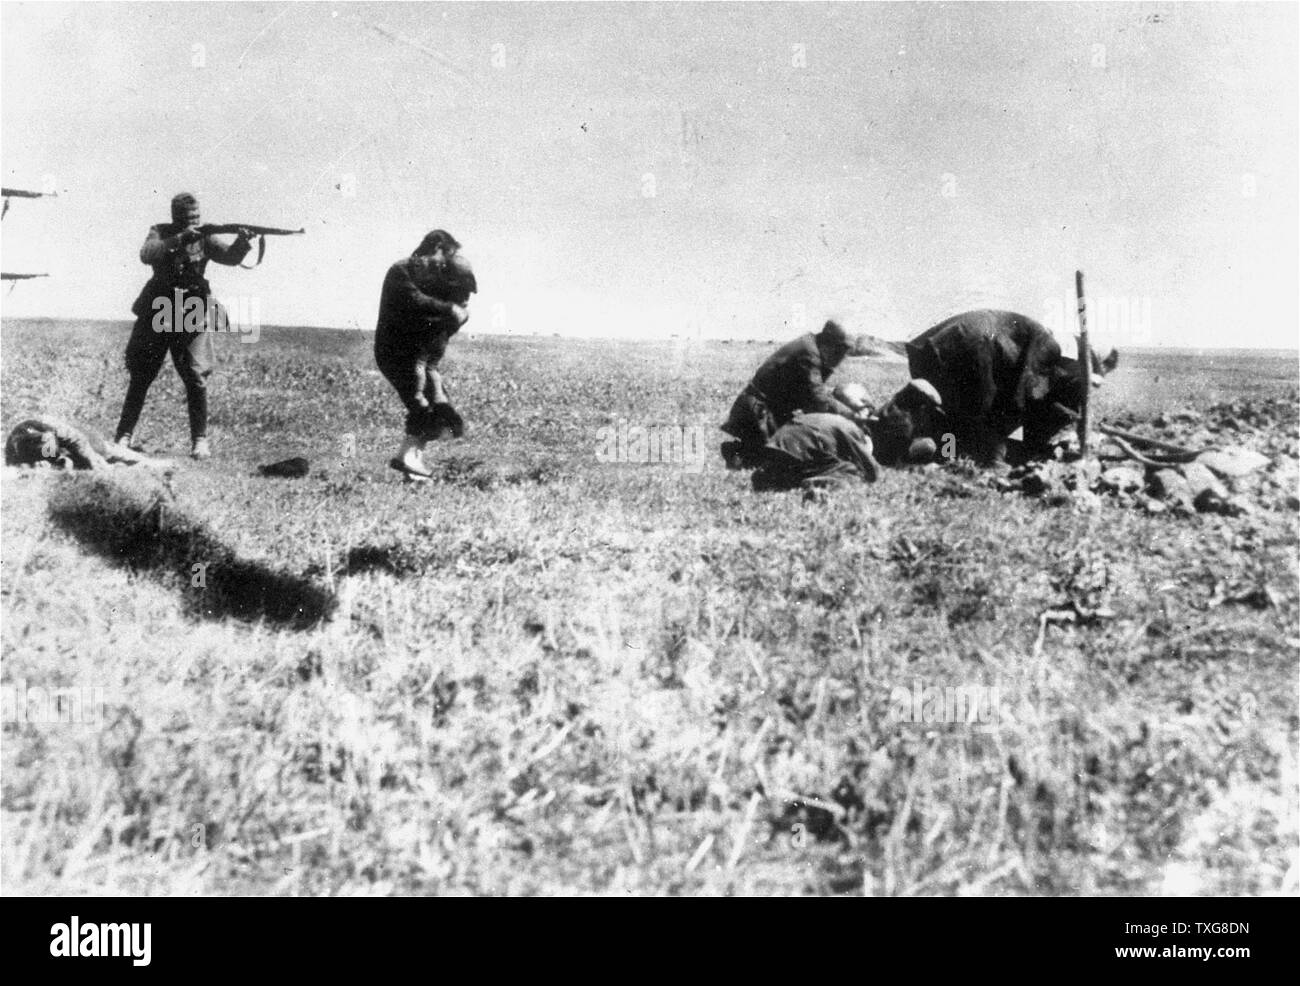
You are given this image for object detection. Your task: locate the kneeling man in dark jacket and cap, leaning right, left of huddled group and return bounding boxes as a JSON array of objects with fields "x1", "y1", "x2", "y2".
[{"x1": 722, "y1": 321, "x2": 861, "y2": 468}]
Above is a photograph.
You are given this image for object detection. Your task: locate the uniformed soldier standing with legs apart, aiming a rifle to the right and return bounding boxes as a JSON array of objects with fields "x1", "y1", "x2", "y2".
[{"x1": 116, "y1": 193, "x2": 251, "y2": 459}]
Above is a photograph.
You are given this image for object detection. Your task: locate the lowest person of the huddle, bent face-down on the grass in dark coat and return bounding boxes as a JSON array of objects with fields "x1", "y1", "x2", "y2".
[{"x1": 751, "y1": 414, "x2": 879, "y2": 490}]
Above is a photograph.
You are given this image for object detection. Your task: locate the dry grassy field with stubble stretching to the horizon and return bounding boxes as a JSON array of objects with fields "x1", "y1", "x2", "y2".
[{"x1": 0, "y1": 321, "x2": 1300, "y2": 895}]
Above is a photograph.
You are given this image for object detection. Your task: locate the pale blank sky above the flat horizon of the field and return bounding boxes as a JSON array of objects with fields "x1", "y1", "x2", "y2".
[{"x1": 3, "y1": 3, "x2": 1300, "y2": 347}]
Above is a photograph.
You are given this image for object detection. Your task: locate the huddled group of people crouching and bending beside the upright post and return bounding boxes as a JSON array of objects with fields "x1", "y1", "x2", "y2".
[{"x1": 722, "y1": 310, "x2": 1118, "y2": 489}]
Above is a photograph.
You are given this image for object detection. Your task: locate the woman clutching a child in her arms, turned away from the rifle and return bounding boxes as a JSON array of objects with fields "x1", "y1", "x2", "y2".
[{"x1": 374, "y1": 229, "x2": 478, "y2": 480}]
